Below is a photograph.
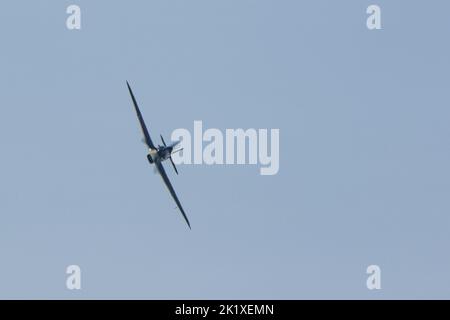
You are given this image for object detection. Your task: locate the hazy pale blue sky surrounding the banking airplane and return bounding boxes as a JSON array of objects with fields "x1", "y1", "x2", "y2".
[{"x1": 0, "y1": 0, "x2": 450, "y2": 299}]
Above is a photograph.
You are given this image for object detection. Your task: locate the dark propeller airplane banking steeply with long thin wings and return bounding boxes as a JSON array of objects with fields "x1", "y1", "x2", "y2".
[{"x1": 127, "y1": 81, "x2": 191, "y2": 229}]
